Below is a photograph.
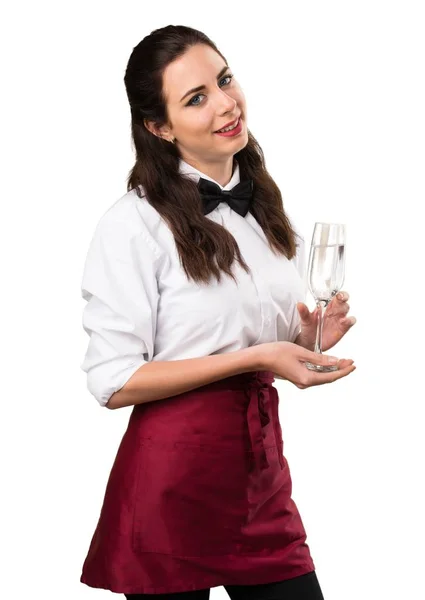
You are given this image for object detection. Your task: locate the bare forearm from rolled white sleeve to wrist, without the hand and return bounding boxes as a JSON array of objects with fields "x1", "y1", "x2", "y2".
[{"x1": 106, "y1": 344, "x2": 266, "y2": 409}]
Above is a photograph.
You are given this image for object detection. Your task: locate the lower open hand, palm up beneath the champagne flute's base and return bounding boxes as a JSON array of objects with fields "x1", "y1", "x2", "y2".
[{"x1": 262, "y1": 342, "x2": 356, "y2": 389}]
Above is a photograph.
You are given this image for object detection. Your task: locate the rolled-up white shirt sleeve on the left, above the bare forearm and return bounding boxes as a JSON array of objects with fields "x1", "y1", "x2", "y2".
[{"x1": 80, "y1": 218, "x2": 158, "y2": 406}]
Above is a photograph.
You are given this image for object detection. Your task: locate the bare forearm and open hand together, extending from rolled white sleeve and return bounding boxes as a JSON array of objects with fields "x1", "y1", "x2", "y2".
[{"x1": 106, "y1": 342, "x2": 356, "y2": 409}]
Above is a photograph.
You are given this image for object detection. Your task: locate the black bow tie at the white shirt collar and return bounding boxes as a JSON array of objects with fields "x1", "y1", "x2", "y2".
[{"x1": 198, "y1": 177, "x2": 254, "y2": 217}]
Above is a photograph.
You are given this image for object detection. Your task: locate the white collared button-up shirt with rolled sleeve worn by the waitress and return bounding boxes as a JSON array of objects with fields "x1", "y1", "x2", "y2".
[{"x1": 81, "y1": 160, "x2": 306, "y2": 406}]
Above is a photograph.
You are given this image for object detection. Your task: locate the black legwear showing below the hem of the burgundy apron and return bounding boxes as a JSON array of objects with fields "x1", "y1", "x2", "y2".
[{"x1": 124, "y1": 571, "x2": 324, "y2": 600}]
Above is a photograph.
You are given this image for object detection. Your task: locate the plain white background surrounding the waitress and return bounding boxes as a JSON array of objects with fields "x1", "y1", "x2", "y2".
[{"x1": 0, "y1": 0, "x2": 425, "y2": 600}]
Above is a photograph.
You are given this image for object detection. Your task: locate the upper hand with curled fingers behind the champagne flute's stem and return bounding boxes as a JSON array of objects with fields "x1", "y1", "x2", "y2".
[{"x1": 296, "y1": 292, "x2": 356, "y2": 352}]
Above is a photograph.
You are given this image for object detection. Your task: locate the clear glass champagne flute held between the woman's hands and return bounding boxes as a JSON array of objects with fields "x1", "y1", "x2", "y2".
[{"x1": 305, "y1": 223, "x2": 346, "y2": 372}]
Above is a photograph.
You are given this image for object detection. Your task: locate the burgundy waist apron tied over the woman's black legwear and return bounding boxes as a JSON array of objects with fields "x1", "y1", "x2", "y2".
[{"x1": 80, "y1": 371, "x2": 315, "y2": 594}]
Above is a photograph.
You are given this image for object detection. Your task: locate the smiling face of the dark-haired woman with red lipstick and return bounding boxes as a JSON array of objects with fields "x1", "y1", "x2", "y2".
[{"x1": 152, "y1": 44, "x2": 248, "y2": 163}]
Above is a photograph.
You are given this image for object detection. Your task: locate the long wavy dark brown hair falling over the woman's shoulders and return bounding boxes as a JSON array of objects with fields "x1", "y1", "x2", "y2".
[{"x1": 124, "y1": 25, "x2": 296, "y2": 283}]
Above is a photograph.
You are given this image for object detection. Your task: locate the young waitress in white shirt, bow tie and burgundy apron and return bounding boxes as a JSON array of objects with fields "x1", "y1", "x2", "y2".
[{"x1": 81, "y1": 26, "x2": 355, "y2": 600}]
